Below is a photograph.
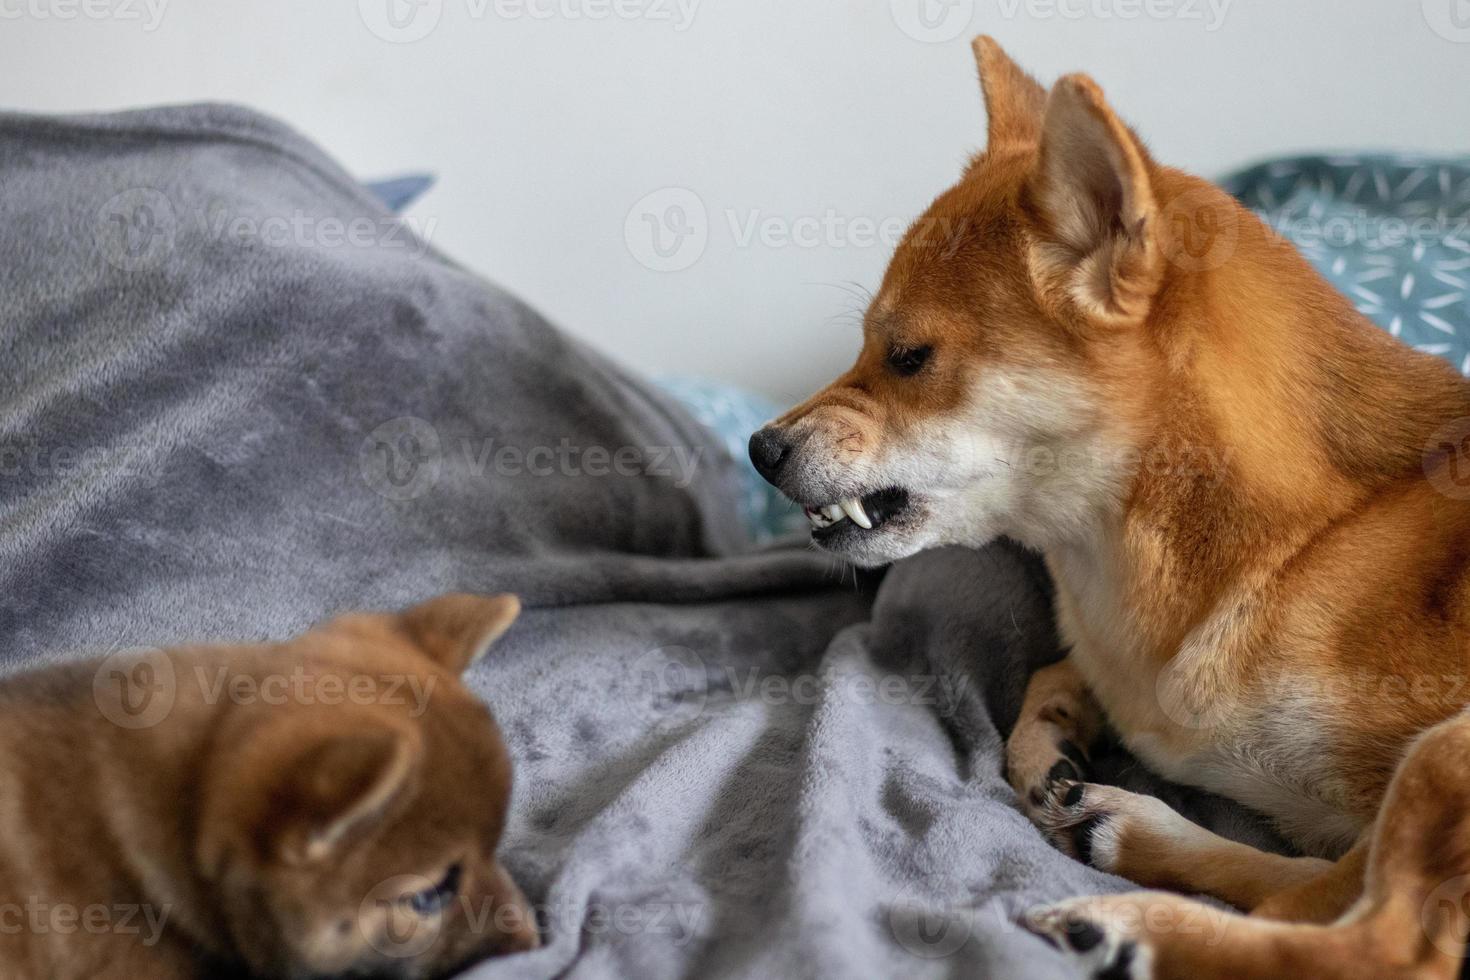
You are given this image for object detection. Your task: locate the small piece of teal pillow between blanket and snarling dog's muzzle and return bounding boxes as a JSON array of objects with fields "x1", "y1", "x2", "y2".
[{"x1": 657, "y1": 378, "x2": 807, "y2": 544}]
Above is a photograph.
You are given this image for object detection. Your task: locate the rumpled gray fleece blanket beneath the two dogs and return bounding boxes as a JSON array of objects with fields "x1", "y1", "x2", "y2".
[{"x1": 0, "y1": 106, "x2": 1287, "y2": 979}]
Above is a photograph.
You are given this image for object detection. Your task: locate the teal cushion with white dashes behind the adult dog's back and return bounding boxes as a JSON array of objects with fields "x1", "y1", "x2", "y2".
[{"x1": 1222, "y1": 154, "x2": 1470, "y2": 373}]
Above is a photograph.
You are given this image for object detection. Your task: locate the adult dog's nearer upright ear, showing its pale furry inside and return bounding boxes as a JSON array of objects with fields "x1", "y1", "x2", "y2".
[{"x1": 1023, "y1": 75, "x2": 1164, "y2": 323}]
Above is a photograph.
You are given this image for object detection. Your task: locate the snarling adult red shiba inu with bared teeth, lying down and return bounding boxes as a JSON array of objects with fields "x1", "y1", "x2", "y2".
[{"x1": 750, "y1": 38, "x2": 1470, "y2": 980}]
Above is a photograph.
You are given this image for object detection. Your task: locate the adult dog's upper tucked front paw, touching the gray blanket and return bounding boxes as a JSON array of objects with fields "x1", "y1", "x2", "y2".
[{"x1": 1005, "y1": 658, "x2": 1103, "y2": 818}]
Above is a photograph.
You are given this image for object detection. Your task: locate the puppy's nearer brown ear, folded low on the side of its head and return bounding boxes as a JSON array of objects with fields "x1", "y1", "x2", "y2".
[{"x1": 198, "y1": 713, "x2": 420, "y2": 877}]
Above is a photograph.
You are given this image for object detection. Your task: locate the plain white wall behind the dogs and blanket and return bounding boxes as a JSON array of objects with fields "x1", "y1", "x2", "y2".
[{"x1": 0, "y1": 0, "x2": 1470, "y2": 398}]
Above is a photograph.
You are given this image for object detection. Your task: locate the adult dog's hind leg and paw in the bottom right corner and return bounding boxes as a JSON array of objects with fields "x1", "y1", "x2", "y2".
[{"x1": 1025, "y1": 714, "x2": 1470, "y2": 980}]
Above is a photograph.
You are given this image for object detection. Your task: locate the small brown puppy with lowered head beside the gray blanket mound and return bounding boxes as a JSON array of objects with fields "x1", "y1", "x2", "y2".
[{"x1": 0, "y1": 595, "x2": 537, "y2": 980}]
